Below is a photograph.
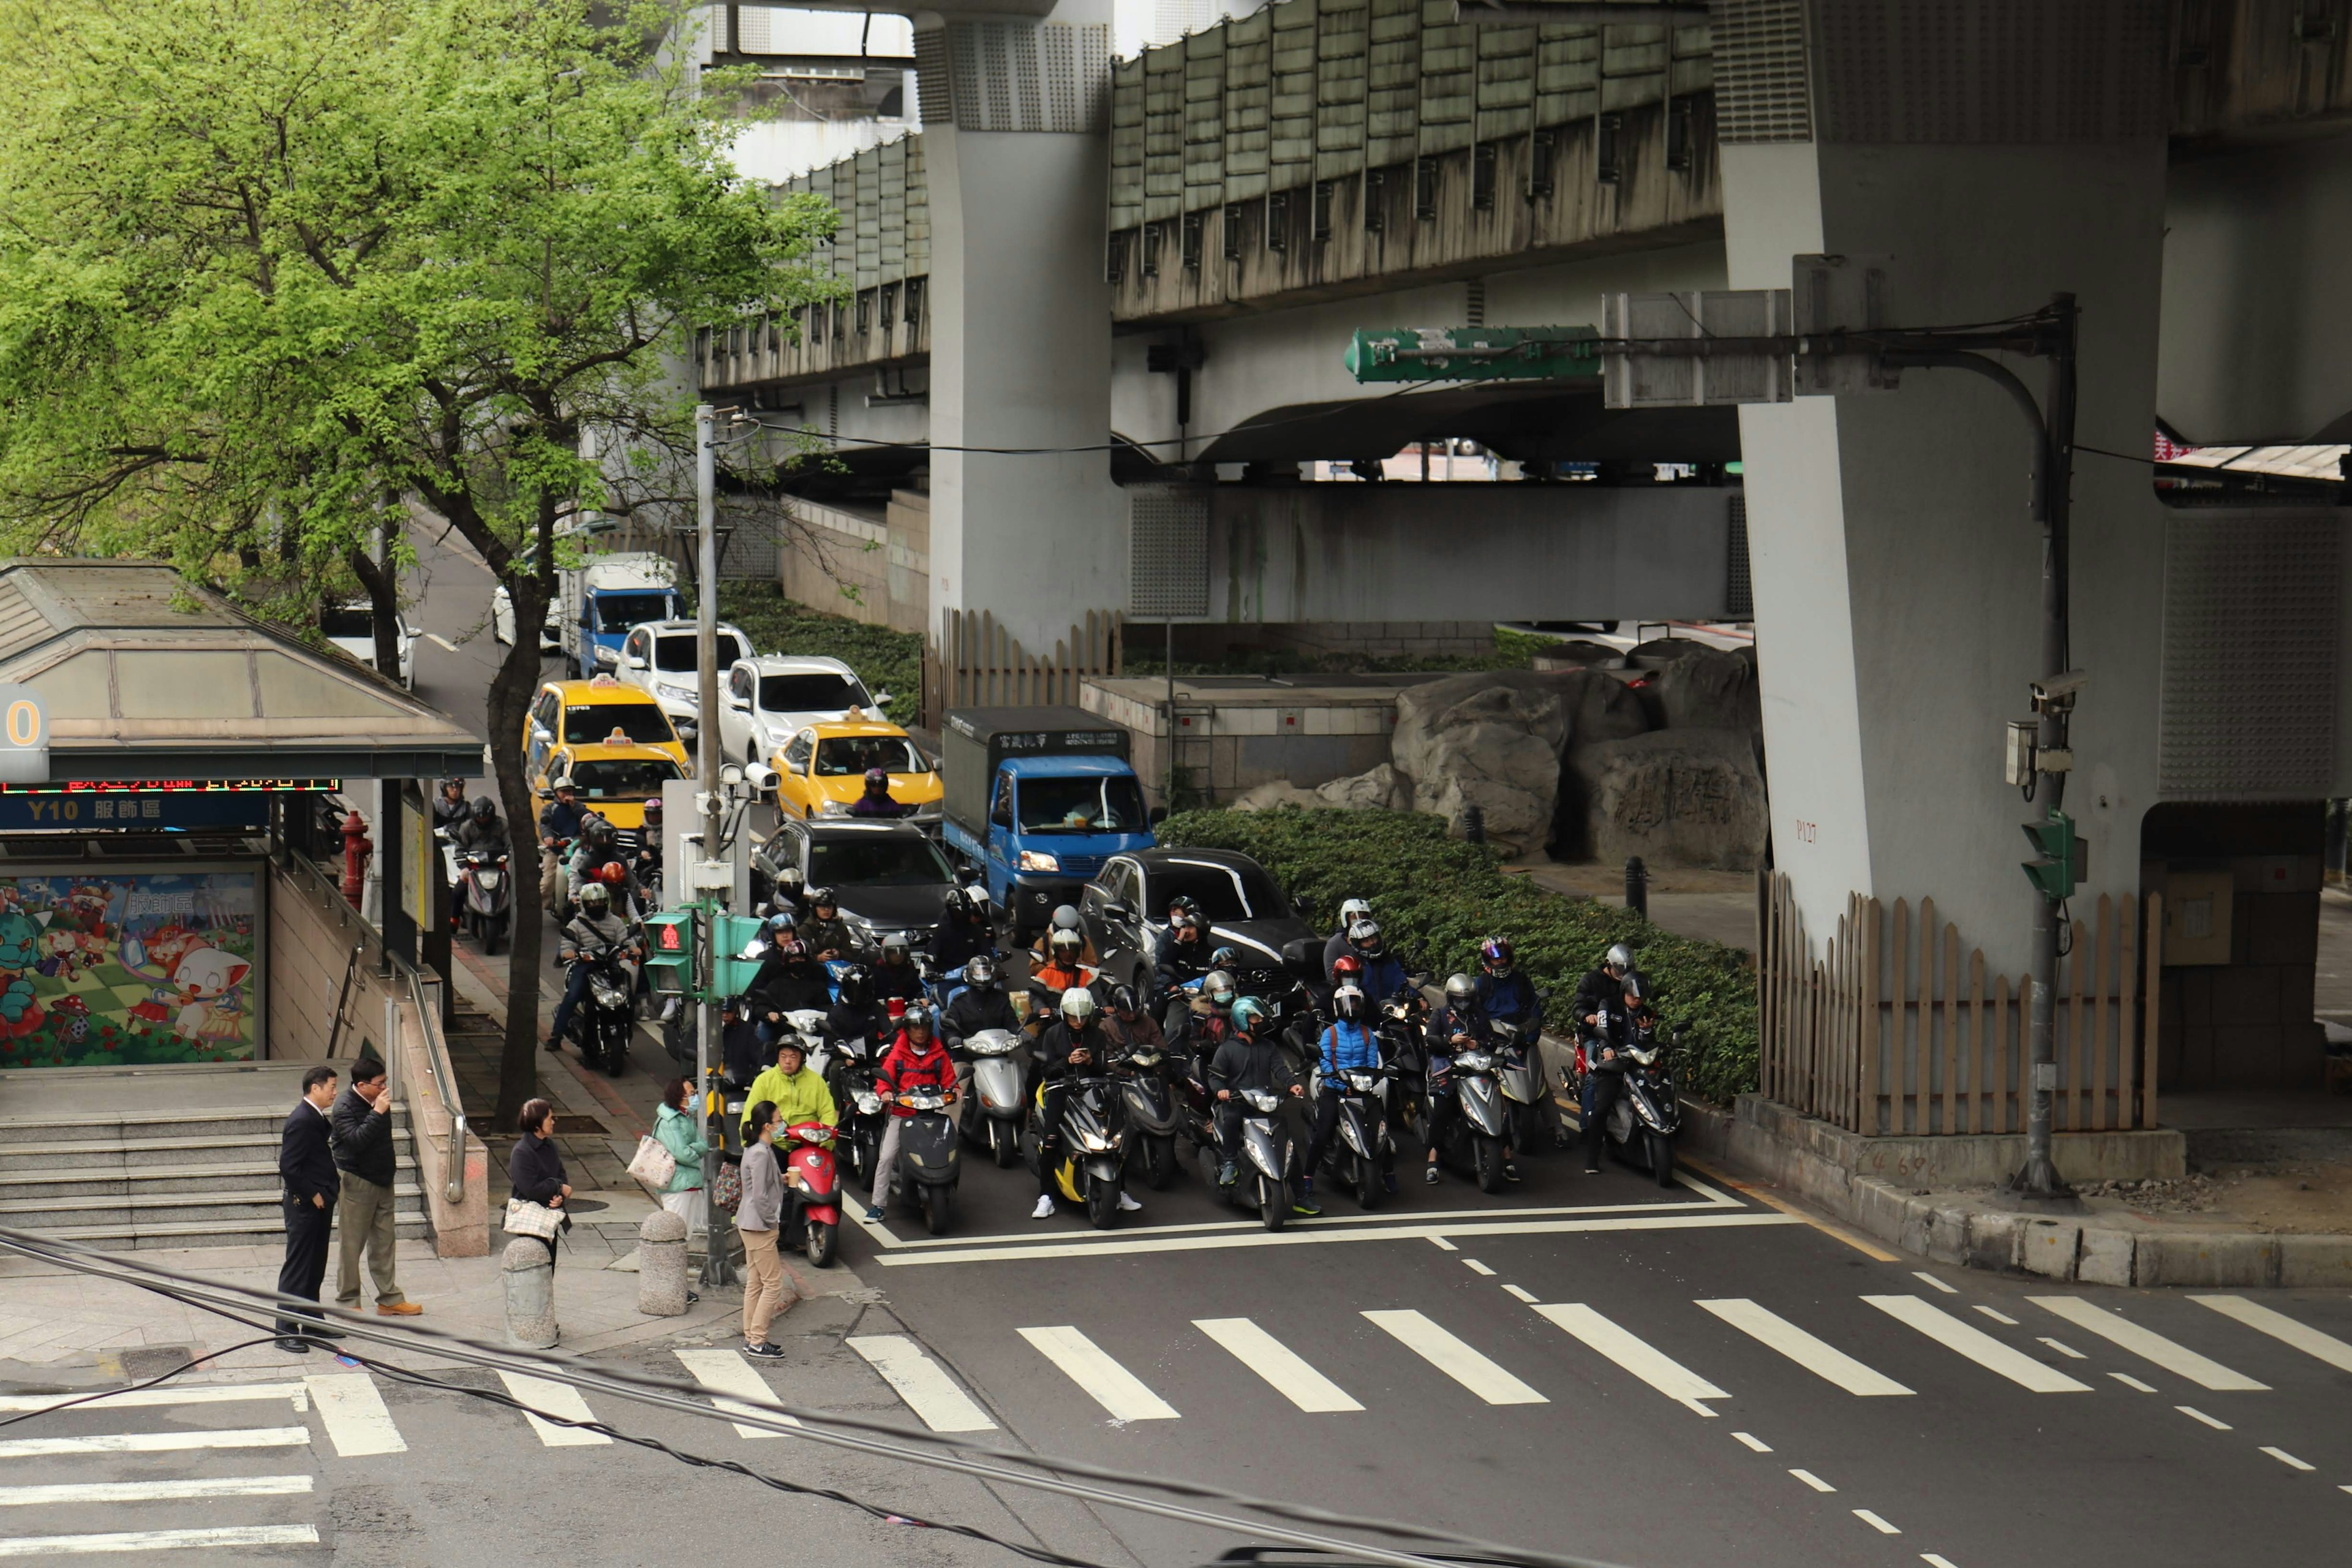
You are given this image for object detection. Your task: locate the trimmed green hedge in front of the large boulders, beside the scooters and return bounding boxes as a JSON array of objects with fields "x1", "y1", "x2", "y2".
[{"x1": 1159, "y1": 809, "x2": 1757, "y2": 1105}]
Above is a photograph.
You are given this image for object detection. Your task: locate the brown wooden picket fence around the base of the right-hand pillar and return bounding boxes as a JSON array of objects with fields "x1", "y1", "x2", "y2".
[{"x1": 1757, "y1": 872, "x2": 2164, "y2": 1136}]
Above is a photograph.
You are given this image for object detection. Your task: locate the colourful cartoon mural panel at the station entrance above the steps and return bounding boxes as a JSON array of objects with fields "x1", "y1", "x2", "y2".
[{"x1": 0, "y1": 870, "x2": 261, "y2": 1067}]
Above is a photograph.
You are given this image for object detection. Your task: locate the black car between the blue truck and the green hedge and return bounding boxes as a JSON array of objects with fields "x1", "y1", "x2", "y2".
[{"x1": 1077, "y1": 849, "x2": 1322, "y2": 990}]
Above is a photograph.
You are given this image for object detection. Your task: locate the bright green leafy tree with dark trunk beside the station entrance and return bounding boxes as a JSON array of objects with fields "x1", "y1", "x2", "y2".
[{"x1": 0, "y1": 0, "x2": 832, "y2": 1126}]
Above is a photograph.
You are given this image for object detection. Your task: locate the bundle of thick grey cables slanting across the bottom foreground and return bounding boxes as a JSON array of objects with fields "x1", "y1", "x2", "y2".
[{"x1": 0, "y1": 1229, "x2": 1607, "y2": 1568}]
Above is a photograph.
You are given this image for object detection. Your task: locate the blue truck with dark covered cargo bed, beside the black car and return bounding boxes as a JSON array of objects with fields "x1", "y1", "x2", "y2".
[{"x1": 938, "y1": 707, "x2": 1157, "y2": 943}]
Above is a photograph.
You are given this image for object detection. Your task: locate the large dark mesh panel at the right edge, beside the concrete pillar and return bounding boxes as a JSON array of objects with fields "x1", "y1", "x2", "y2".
[{"x1": 2154, "y1": 510, "x2": 2345, "y2": 799}]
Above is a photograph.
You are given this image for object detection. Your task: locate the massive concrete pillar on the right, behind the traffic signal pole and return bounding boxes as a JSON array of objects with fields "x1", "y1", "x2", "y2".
[{"x1": 1717, "y1": 0, "x2": 2166, "y2": 973}]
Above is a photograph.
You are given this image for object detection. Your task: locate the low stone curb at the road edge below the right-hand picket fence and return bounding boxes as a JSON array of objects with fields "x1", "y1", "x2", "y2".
[{"x1": 1682, "y1": 1100, "x2": 2352, "y2": 1291}]
